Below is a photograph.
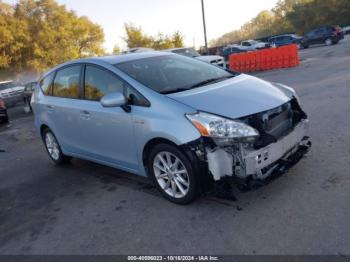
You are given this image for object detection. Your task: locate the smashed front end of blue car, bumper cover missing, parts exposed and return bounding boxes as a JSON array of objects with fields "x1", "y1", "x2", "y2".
[{"x1": 186, "y1": 98, "x2": 311, "y2": 187}]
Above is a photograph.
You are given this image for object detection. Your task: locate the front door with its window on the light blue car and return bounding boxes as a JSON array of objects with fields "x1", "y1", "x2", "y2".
[{"x1": 78, "y1": 64, "x2": 138, "y2": 171}]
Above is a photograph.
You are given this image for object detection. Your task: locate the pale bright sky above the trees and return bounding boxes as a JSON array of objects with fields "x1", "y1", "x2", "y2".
[{"x1": 5, "y1": 0, "x2": 277, "y2": 51}]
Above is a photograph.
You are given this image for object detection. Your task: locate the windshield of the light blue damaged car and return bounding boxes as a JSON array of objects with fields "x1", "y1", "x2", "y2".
[{"x1": 115, "y1": 55, "x2": 235, "y2": 94}]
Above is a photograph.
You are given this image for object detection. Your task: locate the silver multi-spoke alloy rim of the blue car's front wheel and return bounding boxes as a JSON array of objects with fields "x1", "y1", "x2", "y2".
[{"x1": 153, "y1": 152, "x2": 190, "y2": 198}]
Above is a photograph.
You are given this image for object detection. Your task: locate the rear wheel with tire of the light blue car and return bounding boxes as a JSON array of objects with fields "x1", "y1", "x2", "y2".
[{"x1": 42, "y1": 128, "x2": 71, "y2": 165}]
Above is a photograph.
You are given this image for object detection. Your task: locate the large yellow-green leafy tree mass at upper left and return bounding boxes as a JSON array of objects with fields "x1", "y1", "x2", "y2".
[{"x1": 0, "y1": 0, "x2": 104, "y2": 74}]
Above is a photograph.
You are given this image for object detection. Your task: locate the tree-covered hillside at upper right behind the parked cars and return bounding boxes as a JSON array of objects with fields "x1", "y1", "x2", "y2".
[{"x1": 210, "y1": 0, "x2": 350, "y2": 46}]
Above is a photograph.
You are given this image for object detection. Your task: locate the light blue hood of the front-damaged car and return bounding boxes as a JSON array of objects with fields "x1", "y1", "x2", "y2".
[{"x1": 168, "y1": 74, "x2": 293, "y2": 119}]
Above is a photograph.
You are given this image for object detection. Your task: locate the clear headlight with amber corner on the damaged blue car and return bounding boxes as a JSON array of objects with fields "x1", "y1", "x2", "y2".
[{"x1": 186, "y1": 112, "x2": 259, "y2": 145}]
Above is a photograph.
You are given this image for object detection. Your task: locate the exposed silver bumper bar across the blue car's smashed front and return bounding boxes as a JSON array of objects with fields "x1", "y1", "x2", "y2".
[{"x1": 207, "y1": 120, "x2": 311, "y2": 181}]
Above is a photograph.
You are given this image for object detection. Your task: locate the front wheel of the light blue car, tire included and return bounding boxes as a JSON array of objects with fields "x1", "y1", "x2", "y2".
[{"x1": 147, "y1": 144, "x2": 199, "y2": 205}]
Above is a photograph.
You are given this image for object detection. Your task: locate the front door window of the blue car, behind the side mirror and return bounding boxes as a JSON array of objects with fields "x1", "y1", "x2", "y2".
[{"x1": 84, "y1": 65, "x2": 124, "y2": 101}]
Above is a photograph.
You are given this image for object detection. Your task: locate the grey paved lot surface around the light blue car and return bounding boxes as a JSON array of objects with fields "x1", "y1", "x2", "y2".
[{"x1": 0, "y1": 37, "x2": 350, "y2": 254}]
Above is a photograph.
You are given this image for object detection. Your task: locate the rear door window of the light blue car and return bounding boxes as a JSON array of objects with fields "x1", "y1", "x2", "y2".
[{"x1": 53, "y1": 65, "x2": 81, "y2": 99}]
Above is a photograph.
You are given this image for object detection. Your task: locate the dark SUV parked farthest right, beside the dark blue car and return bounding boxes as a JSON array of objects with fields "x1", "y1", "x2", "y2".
[{"x1": 301, "y1": 26, "x2": 344, "y2": 48}]
